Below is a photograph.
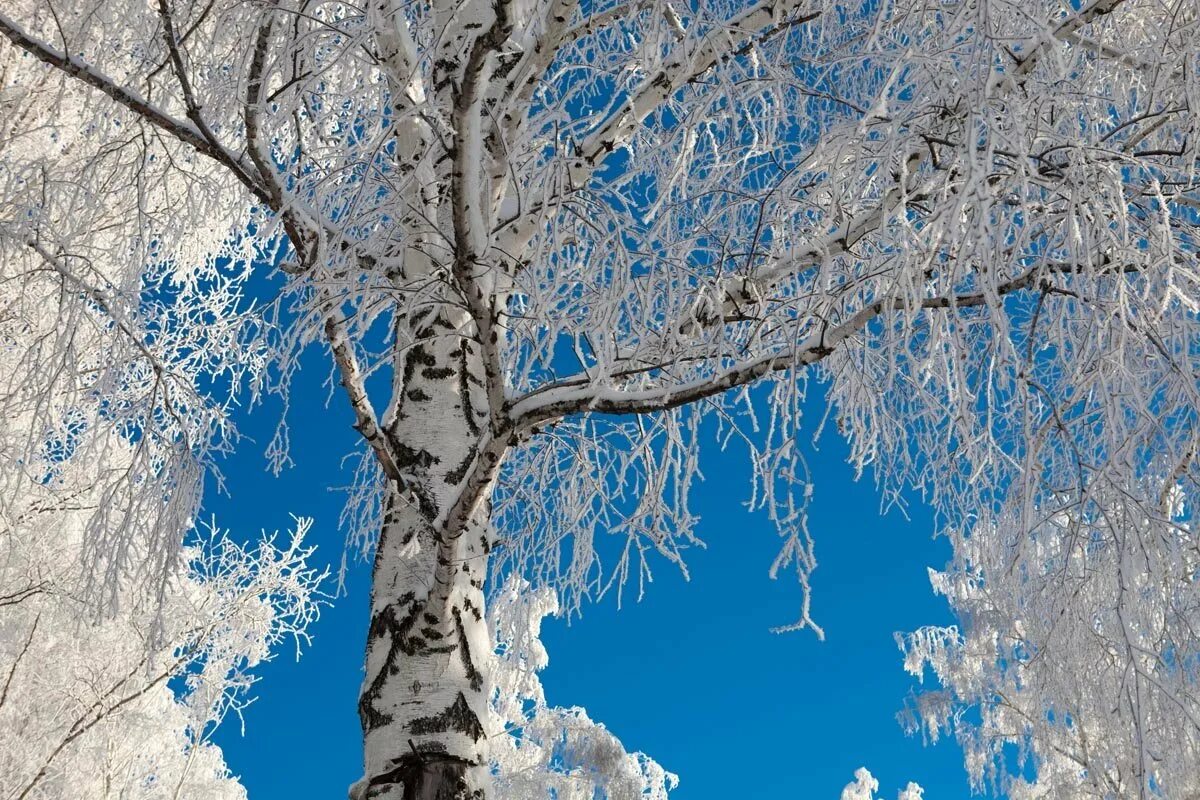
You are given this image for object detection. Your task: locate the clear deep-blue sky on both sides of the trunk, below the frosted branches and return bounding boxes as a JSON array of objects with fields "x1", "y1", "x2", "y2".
[{"x1": 206, "y1": 345, "x2": 968, "y2": 800}]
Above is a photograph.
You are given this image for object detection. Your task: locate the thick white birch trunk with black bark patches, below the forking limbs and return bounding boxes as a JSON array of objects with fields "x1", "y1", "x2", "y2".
[{"x1": 350, "y1": 311, "x2": 491, "y2": 800}]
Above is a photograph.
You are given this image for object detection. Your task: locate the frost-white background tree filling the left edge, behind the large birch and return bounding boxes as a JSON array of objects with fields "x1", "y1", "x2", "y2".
[{"x1": 0, "y1": 98, "x2": 326, "y2": 800}]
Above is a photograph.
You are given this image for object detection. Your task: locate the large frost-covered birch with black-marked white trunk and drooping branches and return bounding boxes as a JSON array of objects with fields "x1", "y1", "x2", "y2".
[{"x1": 0, "y1": 0, "x2": 1200, "y2": 800}]
